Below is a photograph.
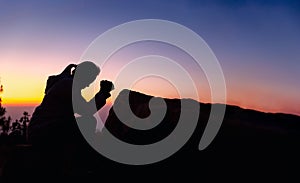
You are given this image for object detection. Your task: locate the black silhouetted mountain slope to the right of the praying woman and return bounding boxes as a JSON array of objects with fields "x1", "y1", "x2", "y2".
[{"x1": 99, "y1": 90, "x2": 300, "y2": 177}]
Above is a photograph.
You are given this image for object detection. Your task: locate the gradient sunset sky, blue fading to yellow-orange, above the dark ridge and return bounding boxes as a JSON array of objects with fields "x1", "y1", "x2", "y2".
[{"x1": 0, "y1": 0, "x2": 300, "y2": 115}]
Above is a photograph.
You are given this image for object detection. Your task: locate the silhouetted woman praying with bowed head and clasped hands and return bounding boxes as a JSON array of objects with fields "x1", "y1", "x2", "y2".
[{"x1": 28, "y1": 61, "x2": 114, "y2": 175}]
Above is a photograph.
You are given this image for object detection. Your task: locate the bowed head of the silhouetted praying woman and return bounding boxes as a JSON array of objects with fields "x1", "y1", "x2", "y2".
[{"x1": 73, "y1": 61, "x2": 100, "y2": 89}]
